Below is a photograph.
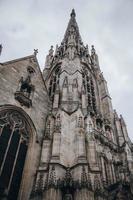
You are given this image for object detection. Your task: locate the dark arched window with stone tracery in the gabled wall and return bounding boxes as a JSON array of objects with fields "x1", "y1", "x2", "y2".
[{"x1": 0, "y1": 111, "x2": 29, "y2": 200}]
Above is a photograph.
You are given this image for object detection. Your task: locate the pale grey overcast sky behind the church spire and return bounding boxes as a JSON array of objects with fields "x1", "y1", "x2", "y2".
[{"x1": 0, "y1": 0, "x2": 133, "y2": 141}]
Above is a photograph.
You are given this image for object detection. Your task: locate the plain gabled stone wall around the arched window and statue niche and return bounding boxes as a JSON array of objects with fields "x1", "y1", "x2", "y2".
[{"x1": 0, "y1": 55, "x2": 49, "y2": 200}]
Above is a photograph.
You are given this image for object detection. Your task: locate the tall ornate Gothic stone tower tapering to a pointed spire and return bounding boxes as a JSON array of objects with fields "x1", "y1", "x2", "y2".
[{"x1": 31, "y1": 10, "x2": 133, "y2": 200}]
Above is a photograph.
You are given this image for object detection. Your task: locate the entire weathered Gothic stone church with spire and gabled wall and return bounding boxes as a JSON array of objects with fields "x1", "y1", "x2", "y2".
[{"x1": 0, "y1": 10, "x2": 133, "y2": 200}]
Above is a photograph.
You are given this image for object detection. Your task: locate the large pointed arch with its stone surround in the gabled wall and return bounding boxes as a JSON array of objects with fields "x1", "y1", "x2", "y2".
[{"x1": 0, "y1": 105, "x2": 38, "y2": 200}]
